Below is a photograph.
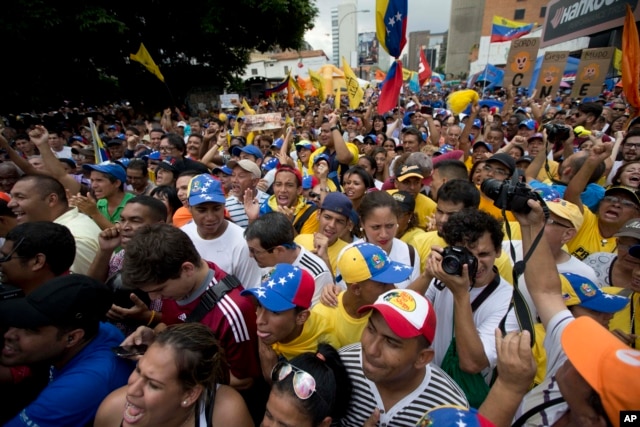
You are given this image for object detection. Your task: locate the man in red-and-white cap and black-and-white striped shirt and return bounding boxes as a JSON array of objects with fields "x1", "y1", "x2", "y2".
[{"x1": 340, "y1": 289, "x2": 468, "y2": 427}]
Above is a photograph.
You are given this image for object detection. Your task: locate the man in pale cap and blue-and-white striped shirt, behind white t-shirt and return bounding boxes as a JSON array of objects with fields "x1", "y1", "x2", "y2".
[{"x1": 225, "y1": 159, "x2": 269, "y2": 228}]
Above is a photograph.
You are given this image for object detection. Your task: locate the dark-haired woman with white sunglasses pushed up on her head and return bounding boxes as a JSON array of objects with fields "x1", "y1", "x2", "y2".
[{"x1": 261, "y1": 344, "x2": 351, "y2": 427}]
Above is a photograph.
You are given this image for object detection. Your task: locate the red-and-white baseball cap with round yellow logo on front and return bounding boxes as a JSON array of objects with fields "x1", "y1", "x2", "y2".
[{"x1": 358, "y1": 289, "x2": 436, "y2": 343}]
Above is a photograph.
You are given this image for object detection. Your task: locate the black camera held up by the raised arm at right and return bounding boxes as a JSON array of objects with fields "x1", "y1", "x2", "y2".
[{"x1": 480, "y1": 175, "x2": 541, "y2": 214}]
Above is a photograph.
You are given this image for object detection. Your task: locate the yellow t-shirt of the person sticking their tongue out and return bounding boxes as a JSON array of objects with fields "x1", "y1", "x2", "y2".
[{"x1": 272, "y1": 310, "x2": 339, "y2": 360}]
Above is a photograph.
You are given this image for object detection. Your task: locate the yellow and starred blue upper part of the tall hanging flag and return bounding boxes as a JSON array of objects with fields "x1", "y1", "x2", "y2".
[{"x1": 376, "y1": 0, "x2": 408, "y2": 58}]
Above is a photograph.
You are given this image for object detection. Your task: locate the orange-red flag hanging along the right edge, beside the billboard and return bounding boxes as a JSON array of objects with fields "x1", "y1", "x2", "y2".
[{"x1": 622, "y1": 4, "x2": 640, "y2": 109}]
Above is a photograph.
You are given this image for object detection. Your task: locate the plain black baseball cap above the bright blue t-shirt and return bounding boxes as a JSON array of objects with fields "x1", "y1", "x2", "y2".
[{"x1": 0, "y1": 274, "x2": 113, "y2": 329}]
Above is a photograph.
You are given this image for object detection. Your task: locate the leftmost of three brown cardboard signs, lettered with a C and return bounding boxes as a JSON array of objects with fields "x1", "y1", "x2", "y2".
[{"x1": 502, "y1": 38, "x2": 540, "y2": 88}]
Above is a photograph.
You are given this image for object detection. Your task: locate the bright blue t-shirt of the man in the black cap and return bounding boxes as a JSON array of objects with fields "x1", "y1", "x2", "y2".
[{"x1": 5, "y1": 323, "x2": 134, "y2": 427}]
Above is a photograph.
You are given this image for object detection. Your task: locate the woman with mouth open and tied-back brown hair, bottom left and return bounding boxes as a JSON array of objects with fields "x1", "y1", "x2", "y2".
[{"x1": 94, "y1": 322, "x2": 253, "y2": 427}]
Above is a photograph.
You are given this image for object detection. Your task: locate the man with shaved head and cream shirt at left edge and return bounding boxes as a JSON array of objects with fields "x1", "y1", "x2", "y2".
[{"x1": 7, "y1": 175, "x2": 100, "y2": 274}]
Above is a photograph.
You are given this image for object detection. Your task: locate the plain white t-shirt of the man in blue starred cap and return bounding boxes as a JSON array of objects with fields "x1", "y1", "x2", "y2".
[{"x1": 180, "y1": 220, "x2": 262, "y2": 289}]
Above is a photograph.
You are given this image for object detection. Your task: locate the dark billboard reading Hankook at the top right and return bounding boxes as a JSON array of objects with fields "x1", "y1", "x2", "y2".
[{"x1": 540, "y1": 0, "x2": 640, "y2": 47}]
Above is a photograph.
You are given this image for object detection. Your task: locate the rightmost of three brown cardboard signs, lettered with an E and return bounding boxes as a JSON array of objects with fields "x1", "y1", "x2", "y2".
[{"x1": 571, "y1": 47, "x2": 616, "y2": 98}]
